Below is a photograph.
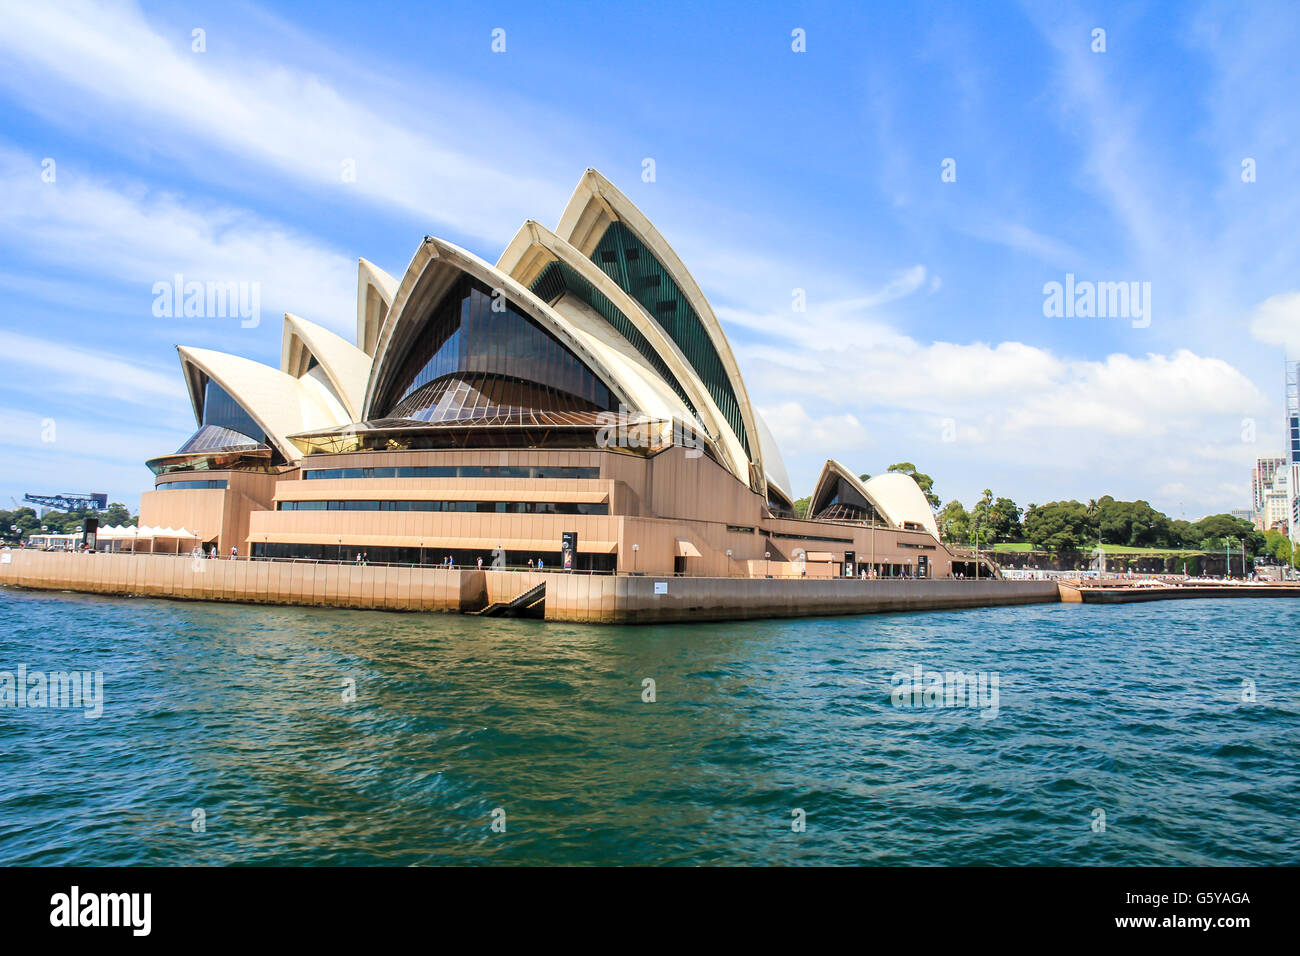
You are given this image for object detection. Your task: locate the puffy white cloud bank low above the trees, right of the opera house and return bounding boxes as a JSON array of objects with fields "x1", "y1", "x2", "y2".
[{"x1": 746, "y1": 327, "x2": 1269, "y2": 510}]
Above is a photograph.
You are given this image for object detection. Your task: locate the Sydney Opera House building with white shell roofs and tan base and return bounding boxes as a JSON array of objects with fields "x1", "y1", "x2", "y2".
[{"x1": 140, "y1": 170, "x2": 963, "y2": 578}]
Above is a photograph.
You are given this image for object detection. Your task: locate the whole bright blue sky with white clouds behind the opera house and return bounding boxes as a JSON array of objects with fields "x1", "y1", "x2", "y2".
[{"x1": 0, "y1": 3, "x2": 1300, "y2": 519}]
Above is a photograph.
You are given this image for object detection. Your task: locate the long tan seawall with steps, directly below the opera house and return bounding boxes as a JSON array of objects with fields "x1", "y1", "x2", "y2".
[{"x1": 0, "y1": 550, "x2": 1061, "y2": 623}]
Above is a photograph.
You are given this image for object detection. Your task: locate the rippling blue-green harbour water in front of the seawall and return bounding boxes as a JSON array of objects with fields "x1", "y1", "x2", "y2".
[{"x1": 0, "y1": 589, "x2": 1300, "y2": 865}]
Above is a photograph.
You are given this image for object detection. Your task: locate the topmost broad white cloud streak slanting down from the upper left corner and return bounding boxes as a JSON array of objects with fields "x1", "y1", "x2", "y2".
[{"x1": 0, "y1": 0, "x2": 567, "y2": 239}]
